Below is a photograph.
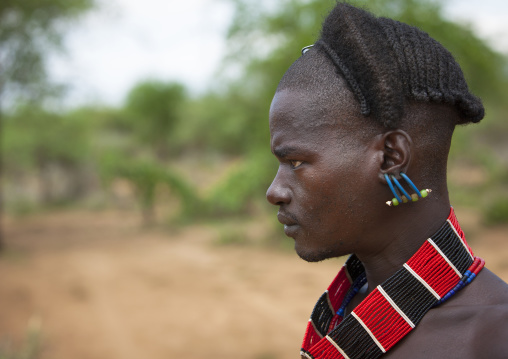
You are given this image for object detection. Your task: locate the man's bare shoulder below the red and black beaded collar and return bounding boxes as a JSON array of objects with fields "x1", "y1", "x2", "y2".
[{"x1": 387, "y1": 268, "x2": 508, "y2": 359}]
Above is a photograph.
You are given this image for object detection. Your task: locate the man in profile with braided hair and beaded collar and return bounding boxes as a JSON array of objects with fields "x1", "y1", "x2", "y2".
[{"x1": 267, "y1": 3, "x2": 508, "y2": 359}]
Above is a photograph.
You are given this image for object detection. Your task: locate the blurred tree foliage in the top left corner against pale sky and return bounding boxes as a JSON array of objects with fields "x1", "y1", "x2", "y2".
[{"x1": 0, "y1": 0, "x2": 94, "y2": 107}]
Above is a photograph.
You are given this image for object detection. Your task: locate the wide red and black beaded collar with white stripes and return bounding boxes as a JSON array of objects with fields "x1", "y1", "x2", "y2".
[{"x1": 300, "y1": 208, "x2": 485, "y2": 359}]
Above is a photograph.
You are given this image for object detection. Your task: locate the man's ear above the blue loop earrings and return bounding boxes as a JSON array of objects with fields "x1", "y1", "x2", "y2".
[{"x1": 378, "y1": 130, "x2": 413, "y2": 183}]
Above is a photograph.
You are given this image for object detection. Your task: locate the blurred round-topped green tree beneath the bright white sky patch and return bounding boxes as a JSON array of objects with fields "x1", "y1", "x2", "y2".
[{"x1": 94, "y1": 80, "x2": 195, "y2": 224}]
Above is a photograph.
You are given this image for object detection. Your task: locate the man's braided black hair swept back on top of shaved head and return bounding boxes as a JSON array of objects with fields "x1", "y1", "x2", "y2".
[{"x1": 315, "y1": 2, "x2": 484, "y2": 128}]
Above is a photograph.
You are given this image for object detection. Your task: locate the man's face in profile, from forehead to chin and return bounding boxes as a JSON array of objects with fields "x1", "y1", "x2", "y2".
[{"x1": 267, "y1": 89, "x2": 376, "y2": 262}]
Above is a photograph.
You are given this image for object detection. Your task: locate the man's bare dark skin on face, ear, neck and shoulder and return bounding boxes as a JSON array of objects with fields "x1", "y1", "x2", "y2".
[{"x1": 267, "y1": 85, "x2": 508, "y2": 358}]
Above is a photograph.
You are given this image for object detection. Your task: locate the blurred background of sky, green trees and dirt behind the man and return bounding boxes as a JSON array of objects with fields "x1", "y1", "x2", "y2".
[{"x1": 0, "y1": 0, "x2": 508, "y2": 359}]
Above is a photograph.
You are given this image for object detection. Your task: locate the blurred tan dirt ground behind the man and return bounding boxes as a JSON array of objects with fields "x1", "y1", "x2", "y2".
[{"x1": 0, "y1": 210, "x2": 508, "y2": 359}]
